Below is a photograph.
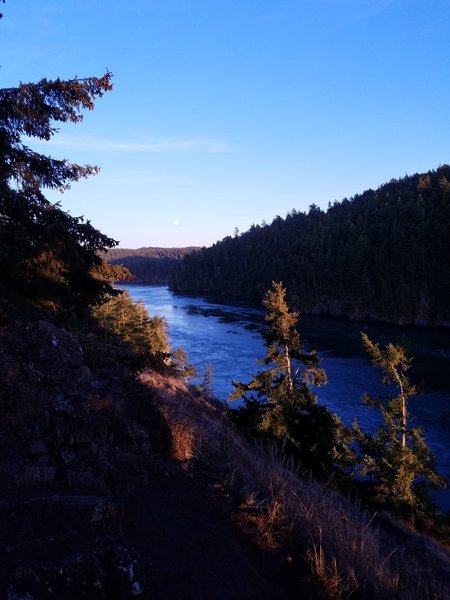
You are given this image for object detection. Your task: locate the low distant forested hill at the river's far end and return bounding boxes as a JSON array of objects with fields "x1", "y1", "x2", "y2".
[{"x1": 107, "y1": 246, "x2": 199, "y2": 283}]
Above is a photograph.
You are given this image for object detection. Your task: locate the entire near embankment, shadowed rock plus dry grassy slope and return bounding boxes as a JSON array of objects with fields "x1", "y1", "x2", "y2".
[{"x1": 0, "y1": 321, "x2": 450, "y2": 600}]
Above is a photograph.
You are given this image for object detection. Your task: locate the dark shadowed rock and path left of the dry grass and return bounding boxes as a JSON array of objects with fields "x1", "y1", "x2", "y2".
[{"x1": 0, "y1": 321, "x2": 302, "y2": 600}]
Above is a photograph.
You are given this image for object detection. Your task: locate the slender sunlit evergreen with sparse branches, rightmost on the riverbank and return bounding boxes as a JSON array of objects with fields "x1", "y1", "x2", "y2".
[{"x1": 353, "y1": 333, "x2": 443, "y2": 509}]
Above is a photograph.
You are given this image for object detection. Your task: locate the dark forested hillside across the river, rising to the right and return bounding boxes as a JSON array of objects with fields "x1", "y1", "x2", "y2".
[{"x1": 170, "y1": 165, "x2": 450, "y2": 327}]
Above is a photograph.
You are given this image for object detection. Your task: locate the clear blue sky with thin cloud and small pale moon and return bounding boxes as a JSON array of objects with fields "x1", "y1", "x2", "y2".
[{"x1": 0, "y1": 0, "x2": 450, "y2": 248}]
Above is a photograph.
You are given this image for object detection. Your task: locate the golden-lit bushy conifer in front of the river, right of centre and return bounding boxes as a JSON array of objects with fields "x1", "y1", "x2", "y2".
[{"x1": 230, "y1": 283, "x2": 351, "y2": 478}]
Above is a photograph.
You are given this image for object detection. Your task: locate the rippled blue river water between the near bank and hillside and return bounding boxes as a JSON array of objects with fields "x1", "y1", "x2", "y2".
[{"x1": 121, "y1": 284, "x2": 450, "y2": 509}]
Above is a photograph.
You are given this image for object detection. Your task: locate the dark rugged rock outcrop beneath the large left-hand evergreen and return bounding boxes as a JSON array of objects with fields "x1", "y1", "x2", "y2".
[{"x1": 0, "y1": 321, "x2": 156, "y2": 600}]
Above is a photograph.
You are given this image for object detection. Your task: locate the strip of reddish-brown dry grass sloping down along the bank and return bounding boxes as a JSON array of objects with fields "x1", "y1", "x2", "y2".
[{"x1": 142, "y1": 374, "x2": 450, "y2": 600}]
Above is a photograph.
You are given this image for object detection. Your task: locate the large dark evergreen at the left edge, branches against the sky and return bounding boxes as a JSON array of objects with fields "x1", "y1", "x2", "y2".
[{"x1": 0, "y1": 55, "x2": 117, "y2": 314}]
